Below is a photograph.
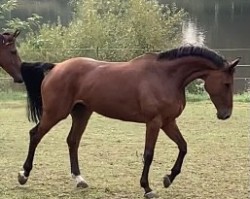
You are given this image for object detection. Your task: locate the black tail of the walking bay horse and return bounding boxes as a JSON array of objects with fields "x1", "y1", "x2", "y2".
[{"x1": 21, "y1": 62, "x2": 55, "y2": 123}]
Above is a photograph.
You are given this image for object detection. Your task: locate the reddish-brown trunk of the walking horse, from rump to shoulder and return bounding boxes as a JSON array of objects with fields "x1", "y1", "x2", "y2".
[{"x1": 39, "y1": 55, "x2": 184, "y2": 122}]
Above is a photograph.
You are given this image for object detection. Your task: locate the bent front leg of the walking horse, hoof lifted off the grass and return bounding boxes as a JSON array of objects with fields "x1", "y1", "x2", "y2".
[{"x1": 162, "y1": 121, "x2": 187, "y2": 188}]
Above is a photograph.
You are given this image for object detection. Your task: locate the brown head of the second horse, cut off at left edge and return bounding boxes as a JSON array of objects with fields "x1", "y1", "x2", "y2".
[{"x1": 0, "y1": 30, "x2": 23, "y2": 83}]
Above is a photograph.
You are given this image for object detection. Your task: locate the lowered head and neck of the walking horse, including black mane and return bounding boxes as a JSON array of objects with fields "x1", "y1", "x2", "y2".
[{"x1": 159, "y1": 45, "x2": 240, "y2": 120}]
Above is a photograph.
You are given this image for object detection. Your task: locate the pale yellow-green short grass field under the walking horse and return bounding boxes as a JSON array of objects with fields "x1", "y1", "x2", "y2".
[{"x1": 0, "y1": 101, "x2": 250, "y2": 199}]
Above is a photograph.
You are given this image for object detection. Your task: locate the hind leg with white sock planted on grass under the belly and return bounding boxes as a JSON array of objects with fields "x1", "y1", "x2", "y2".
[{"x1": 67, "y1": 103, "x2": 92, "y2": 188}]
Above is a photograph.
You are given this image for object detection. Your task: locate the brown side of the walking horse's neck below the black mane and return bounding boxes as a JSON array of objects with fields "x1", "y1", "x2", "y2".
[{"x1": 163, "y1": 57, "x2": 215, "y2": 89}]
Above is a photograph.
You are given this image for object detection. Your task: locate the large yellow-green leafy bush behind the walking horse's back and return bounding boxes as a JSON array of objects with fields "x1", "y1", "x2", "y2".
[{"x1": 21, "y1": 0, "x2": 185, "y2": 61}]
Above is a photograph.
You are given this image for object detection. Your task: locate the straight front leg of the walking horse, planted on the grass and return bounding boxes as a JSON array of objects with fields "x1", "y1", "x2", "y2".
[{"x1": 140, "y1": 118, "x2": 161, "y2": 198}]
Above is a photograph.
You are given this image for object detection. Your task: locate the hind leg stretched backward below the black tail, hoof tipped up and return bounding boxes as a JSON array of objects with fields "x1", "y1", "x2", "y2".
[{"x1": 18, "y1": 112, "x2": 62, "y2": 185}]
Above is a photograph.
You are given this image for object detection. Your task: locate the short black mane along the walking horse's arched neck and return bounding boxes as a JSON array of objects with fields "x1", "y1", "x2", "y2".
[{"x1": 157, "y1": 45, "x2": 226, "y2": 67}]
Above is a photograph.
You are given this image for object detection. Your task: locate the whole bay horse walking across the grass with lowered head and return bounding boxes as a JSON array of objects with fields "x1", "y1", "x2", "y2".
[{"x1": 18, "y1": 46, "x2": 240, "y2": 198}]
